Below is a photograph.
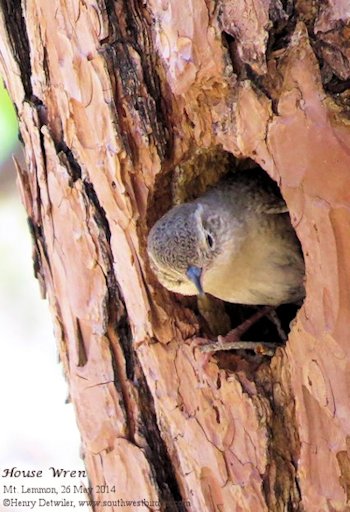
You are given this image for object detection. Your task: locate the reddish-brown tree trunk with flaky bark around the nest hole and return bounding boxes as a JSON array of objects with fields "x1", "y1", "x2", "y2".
[{"x1": 0, "y1": 0, "x2": 350, "y2": 512}]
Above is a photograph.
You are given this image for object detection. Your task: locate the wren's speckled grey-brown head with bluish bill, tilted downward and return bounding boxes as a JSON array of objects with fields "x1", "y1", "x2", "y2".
[{"x1": 148, "y1": 201, "x2": 223, "y2": 295}]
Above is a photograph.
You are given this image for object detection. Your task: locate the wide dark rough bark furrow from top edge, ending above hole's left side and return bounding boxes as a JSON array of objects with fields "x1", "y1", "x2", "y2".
[{"x1": 102, "y1": 0, "x2": 172, "y2": 160}]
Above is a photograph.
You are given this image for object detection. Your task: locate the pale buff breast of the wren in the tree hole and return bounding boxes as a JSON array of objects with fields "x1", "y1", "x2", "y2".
[{"x1": 202, "y1": 219, "x2": 304, "y2": 306}]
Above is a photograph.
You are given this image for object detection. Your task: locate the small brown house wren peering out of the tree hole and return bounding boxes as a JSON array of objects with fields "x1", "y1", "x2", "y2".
[{"x1": 148, "y1": 169, "x2": 305, "y2": 352}]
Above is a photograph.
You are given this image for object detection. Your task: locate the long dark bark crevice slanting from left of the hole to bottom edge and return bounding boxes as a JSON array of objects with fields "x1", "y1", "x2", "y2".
[{"x1": 83, "y1": 176, "x2": 181, "y2": 512}]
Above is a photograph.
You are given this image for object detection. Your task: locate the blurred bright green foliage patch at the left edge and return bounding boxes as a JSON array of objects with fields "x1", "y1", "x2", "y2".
[{"x1": 0, "y1": 77, "x2": 18, "y2": 165}]
